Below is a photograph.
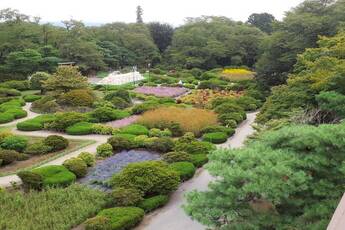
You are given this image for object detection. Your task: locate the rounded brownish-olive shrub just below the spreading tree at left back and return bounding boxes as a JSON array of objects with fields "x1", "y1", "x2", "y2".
[{"x1": 57, "y1": 89, "x2": 96, "y2": 107}]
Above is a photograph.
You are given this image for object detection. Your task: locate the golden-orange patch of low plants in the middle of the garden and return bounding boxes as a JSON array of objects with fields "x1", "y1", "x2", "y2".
[{"x1": 138, "y1": 107, "x2": 217, "y2": 136}]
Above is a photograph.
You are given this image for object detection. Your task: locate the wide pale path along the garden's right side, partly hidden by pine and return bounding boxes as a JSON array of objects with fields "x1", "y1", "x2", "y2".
[{"x1": 136, "y1": 113, "x2": 257, "y2": 230}]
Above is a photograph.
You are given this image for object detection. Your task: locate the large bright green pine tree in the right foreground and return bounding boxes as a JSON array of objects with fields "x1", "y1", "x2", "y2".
[{"x1": 186, "y1": 124, "x2": 345, "y2": 229}]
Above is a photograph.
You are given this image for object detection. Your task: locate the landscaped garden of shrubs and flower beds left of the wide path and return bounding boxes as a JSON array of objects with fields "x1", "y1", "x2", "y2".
[{"x1": 0, "y1": 67, "x2": 262, "y2": 229}]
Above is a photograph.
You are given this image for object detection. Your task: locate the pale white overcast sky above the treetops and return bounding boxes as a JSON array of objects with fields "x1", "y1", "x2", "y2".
[{"x1": 0, "y1": 0, "x2": 303, "y2": 26}]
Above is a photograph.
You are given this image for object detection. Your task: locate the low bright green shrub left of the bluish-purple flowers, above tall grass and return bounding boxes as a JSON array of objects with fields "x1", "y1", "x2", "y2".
[{"x1": 31, "y1": 165, "x2": 76, "y2": 187}]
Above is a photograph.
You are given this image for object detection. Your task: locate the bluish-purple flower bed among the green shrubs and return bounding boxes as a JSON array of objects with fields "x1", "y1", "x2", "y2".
[{"x1": 79, "y1": 150, "x2": 160, "y2": 191}]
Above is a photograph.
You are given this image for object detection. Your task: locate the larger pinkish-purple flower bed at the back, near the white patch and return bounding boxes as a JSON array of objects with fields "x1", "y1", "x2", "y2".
[{"x1": 134, "y1": 86, "x2": 188, "y2": 97}]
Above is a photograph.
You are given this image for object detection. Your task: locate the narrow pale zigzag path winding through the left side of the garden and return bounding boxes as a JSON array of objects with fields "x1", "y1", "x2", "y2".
[{"x1": 0, "y1": 103, "x2": 110, "y2": 187}]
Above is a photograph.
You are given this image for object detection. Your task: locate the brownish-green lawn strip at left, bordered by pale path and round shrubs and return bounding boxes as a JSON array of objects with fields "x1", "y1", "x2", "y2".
[{"x1": 0, "y1": 136, "x2": 95, "y2": 177}]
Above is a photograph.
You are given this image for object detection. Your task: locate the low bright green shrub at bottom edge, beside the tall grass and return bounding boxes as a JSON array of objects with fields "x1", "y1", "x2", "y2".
[{"x1": 85, "y1": 207, "x2": 144, "y2": 230}]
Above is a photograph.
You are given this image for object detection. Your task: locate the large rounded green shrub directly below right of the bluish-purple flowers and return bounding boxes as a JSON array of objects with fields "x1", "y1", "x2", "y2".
[{"x1": 110, "y1": 161, "x2": 179, "y2": 196}]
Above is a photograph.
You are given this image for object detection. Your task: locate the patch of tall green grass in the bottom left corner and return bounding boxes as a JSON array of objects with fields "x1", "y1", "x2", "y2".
[{"x1": 0, "y1": 184, "x2": 108, "y2": 230}]
